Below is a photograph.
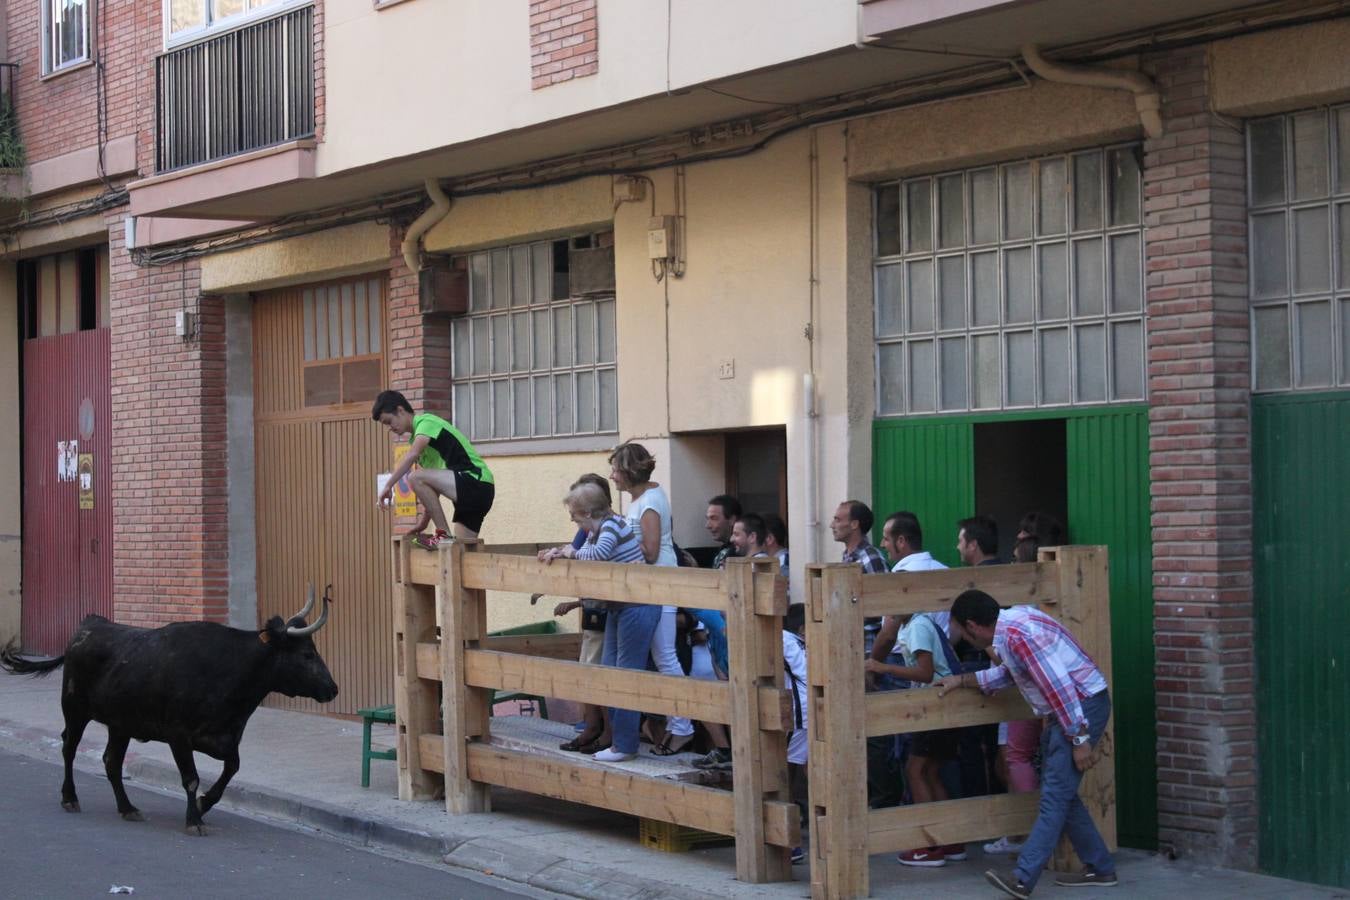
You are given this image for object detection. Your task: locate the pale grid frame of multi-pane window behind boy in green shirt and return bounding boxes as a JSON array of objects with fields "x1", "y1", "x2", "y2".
[{"x1": 451, "y1": 235, "x2": 620, "y2": 452}]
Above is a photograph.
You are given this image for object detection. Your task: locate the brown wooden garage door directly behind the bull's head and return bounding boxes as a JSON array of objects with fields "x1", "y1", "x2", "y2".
[{"x1": 254, "y1": 275, "x2": 394, "y2": 714}]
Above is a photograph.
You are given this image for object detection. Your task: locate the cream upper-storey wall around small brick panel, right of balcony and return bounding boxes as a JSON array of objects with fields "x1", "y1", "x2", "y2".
[{"x1": 317, "y1": 0, "x2": 856, "y2": 175}]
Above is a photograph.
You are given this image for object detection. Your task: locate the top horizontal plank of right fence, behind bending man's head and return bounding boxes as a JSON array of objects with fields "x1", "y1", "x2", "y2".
[{"x1": 863, "y1": 563, "x2": 1060, "y2": 615}]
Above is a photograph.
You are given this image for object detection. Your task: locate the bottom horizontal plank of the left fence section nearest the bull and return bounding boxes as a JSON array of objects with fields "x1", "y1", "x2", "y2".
[{"x1": 461, "y1": 735, "x2": 802, "y2": 847}]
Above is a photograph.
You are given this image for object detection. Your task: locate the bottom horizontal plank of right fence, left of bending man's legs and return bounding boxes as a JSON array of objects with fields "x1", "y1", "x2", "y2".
[{"x1": 858, "y1": 793, "x2": 1041, "y2": 854}]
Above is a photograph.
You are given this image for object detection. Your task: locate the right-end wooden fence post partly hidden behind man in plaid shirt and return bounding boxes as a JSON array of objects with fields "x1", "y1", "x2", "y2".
[{"x1": 1041, "y1": 546, "x2": 1116, "y2": 872}]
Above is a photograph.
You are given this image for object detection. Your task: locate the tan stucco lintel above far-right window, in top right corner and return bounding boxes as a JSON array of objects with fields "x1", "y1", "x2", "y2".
[{"x1": 1210, "y1": 19, "x2": 1350, "y2": 116}]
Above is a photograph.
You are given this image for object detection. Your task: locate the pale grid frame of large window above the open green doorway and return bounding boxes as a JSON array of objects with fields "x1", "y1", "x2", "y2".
[{"x1": 872, "y1": 143, "x2": 1148, "y2": 418}]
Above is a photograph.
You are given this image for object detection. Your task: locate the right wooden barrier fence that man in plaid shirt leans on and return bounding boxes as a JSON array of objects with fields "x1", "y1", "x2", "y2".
[{"x1": 804, "y1": 546, "x2": 1116, "y2": 900}]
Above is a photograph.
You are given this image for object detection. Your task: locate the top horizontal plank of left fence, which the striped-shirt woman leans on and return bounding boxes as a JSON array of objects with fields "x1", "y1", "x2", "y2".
[{"x1": 464, "y1": 553, "x2": 726, "y2": 611}]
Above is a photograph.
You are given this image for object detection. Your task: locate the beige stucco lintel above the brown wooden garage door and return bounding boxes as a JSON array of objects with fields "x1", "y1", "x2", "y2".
[{"x1": 201, "y1": 221, "x2": 389, "y2": 294}]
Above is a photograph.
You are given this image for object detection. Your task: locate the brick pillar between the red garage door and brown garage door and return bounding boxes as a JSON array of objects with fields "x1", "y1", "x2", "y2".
[{"x1": 108, "y1": 218, "x2": 230, "y2": 625}]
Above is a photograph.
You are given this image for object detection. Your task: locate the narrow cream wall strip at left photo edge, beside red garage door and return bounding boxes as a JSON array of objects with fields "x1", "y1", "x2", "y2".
[{"x1": 0, "y1": 262, "x2": 23, "y2": 646}]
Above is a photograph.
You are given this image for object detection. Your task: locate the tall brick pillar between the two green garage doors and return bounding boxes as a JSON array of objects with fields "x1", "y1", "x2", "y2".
[{"x1": 1145, "y1": 47, "x2": 1257, "y2": 866}]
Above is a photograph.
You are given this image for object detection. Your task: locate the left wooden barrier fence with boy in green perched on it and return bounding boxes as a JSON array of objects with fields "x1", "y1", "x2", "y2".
[{"x1": 393, "y1": 538, "x2": 799, "y2": 882}]
